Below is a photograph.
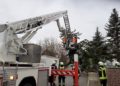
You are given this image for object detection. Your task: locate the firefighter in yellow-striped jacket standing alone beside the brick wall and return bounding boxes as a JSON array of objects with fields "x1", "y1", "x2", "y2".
[{"x1": 98, "y1": 61, "x2": 107, "y2": 86}]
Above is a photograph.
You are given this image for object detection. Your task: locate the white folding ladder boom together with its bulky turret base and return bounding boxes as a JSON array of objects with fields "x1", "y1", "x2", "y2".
[{"x1": 0, "y1": 11, "x2": 71, "y2": 61}]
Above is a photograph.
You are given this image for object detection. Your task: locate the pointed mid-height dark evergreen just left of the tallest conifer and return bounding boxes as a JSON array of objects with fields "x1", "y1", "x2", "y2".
[{"x1": 91, "y1": 27, "x2": 107, "y2": 65}]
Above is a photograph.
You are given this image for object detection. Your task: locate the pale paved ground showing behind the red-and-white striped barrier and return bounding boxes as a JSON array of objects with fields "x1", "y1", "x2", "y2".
[{"x1": 48, "y1": 72, "x2": 100, "y2": 86}]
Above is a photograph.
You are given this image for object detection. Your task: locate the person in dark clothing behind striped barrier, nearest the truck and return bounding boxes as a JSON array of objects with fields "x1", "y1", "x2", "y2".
[{"x1": 49, "y1": 61, "x2": 57, "y2": 86}]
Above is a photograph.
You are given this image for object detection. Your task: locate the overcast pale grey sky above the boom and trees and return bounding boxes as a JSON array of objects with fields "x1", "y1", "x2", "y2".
[{"x1": 0, "y1": 0, "x2": 120, "y2": 43}]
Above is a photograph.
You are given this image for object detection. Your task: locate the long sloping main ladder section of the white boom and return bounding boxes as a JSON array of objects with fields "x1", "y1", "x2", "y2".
[{"x1": 7, "y1": 11, "x2": 69, "y2": 33}]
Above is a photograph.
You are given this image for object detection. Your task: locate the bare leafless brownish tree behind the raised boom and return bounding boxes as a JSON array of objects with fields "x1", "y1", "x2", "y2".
[{"x1": 39, "y1": 38, "x2": 68, "y2": 62}]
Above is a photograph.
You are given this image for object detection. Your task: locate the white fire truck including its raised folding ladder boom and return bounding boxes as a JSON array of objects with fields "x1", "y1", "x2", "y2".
[{"x1": 0, "y1": 11, "x2": 71, "y2": 86}]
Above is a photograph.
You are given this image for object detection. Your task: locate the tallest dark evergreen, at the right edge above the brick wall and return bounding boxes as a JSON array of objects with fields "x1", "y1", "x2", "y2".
[{"x1": 105, "y1": 9, "x2": 120, "y2": 60}]
